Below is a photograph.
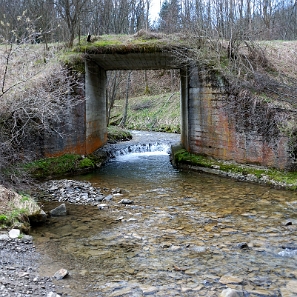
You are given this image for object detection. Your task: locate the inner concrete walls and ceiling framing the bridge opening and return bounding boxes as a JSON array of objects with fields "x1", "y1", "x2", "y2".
[{"x1": 85, "y1": 52, "x2": 188, "y2": 154}]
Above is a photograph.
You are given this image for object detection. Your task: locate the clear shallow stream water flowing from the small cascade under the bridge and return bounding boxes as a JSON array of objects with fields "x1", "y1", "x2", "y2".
[{"x1": 33, "y1": 132, "x2": 297, "y2": 297}]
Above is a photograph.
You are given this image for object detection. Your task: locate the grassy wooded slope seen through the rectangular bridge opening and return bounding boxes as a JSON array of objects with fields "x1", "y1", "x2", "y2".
[{"x1": 106, "y1": 69, "x2": 181, "y2": 133}]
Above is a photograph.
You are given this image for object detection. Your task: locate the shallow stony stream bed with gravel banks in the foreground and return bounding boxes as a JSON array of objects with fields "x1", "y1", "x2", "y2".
[{"x1": 0, "y1": 130, "x2": 297, "y2": 297}]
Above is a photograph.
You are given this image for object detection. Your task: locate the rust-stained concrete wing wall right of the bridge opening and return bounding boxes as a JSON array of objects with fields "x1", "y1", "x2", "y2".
[{"x1": 187, "y1": 67, "x2": 292, "y2": 169}]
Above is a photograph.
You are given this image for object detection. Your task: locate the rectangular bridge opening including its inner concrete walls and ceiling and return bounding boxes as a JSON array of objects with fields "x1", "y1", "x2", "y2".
[{"x1": 85, "y1": 52, "x2": 188, "y2": 154}]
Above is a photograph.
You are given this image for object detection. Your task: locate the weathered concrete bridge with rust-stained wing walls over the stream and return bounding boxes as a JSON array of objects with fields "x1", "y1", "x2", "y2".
[{"x1": 44, "y1": 46, "x2": 292, "y2": 169}]
